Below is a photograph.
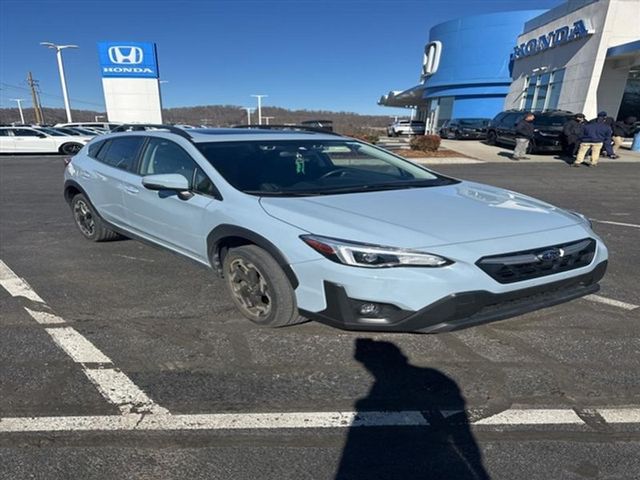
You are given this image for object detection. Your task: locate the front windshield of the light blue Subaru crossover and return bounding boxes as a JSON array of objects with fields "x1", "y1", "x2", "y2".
[{"x1": 198, "y1": 140, "x2": 457, "y2": 196}]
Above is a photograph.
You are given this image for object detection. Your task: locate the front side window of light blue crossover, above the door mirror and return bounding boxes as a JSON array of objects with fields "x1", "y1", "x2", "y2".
[{"x1": 140, "y1": 138, "x2": 196, "y2": 184}]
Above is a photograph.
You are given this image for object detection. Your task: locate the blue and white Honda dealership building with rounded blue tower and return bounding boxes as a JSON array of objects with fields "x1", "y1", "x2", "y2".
[{"x1": 378, "y1": 0, "x2": 640, "y2": 130}]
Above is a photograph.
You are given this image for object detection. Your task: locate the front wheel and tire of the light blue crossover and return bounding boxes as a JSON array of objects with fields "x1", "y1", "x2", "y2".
[{"x1": 223, "y1": 245, "x2": 304, "y2": 327}]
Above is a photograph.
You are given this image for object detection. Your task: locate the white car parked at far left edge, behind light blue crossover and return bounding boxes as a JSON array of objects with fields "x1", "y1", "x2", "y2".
[{"x1": 0, "y1": 127, "x2": 93, "y2": 155}]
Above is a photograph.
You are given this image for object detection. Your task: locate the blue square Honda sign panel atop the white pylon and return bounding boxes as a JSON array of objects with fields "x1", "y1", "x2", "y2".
[{"x1": 98, "y1": 42, "x2": 159, "y2": 78}]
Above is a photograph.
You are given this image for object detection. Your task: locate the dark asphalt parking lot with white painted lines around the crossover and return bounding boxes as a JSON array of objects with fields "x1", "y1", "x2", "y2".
[{"x1": 0, "y1": 156, "x2": 640, "y2": 480}]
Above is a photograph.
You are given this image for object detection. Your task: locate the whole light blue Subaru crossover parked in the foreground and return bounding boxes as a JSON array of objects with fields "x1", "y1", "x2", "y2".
[{"x1": 64, "y1": 125, "x2": 608, "y2": 332}]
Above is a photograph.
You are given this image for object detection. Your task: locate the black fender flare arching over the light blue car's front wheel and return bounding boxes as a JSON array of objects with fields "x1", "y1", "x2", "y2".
[{"x1": 207, "y1": 224, "x2": 300, "y2": 289}]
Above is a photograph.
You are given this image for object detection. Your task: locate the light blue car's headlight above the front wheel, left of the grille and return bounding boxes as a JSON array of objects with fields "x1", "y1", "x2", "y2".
[{"x1": 300, "y1": 235, "x2": 453, "y2": 268}]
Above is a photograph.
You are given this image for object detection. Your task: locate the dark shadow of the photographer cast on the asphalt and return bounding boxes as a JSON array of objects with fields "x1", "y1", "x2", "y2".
[{"x1": 336, "y1": 338, "x2": 489, "y2": 480}]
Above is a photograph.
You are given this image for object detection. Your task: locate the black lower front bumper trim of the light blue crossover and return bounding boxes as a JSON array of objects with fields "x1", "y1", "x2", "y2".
[{"x1": 300, "y1": 260, "x2": 607, "y2": 333}]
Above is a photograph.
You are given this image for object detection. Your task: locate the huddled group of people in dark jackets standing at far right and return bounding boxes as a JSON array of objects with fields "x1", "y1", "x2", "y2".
[{"x1": 562, "y1": 112, "x2": 636, "y2": 167}]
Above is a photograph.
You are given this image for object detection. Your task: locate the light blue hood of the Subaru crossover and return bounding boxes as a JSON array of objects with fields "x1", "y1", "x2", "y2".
[{"x1": 260, "y1": 182, "x2": 581, "y2": 248}]
